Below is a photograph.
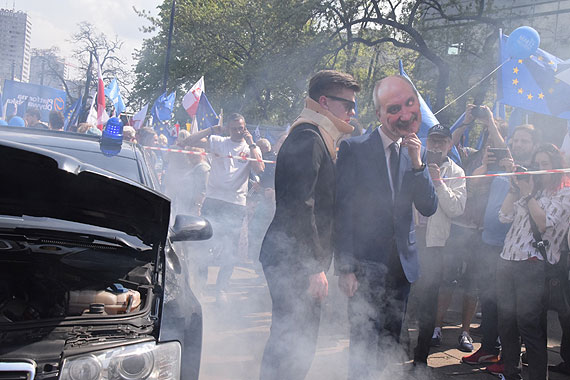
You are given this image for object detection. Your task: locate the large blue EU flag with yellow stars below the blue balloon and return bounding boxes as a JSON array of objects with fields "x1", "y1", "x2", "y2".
[{"x1": 497, "y1": 33, "x2": 570, "y2": 119}]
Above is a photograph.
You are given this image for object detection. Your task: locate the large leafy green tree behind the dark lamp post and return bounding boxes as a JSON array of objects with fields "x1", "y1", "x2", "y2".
[{"x1": 135, "y1": 0, "x2": 329, "y2": 123}]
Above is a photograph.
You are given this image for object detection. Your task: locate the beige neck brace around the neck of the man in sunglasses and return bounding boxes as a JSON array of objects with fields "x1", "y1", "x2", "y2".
[{"x1": 289, "y1": 98, "x2": 354, "y2": 160}]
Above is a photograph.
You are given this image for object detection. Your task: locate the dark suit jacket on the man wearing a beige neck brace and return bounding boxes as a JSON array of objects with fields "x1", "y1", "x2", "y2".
[{"x1": 259, "y1": 124, "x2": 335, "y2": 274}]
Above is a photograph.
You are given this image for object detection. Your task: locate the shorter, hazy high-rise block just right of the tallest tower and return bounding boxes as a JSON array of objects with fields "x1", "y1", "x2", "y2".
[{"x1": 30, "y1": 49, "x2": 67, "y2": 89}]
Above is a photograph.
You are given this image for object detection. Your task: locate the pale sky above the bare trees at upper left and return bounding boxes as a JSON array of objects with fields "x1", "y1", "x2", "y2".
[{"x1": 11, "y1": 0, "x2": 163, "y2": 74}]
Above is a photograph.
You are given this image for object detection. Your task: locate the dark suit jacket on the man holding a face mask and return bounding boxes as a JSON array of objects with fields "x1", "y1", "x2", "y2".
[{"x1": 335, "y1": 131, "x2": 437, "y2": 283}]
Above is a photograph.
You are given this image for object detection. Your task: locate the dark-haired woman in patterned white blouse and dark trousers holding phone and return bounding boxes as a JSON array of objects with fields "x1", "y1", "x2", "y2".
[{"x1": 497, "y1": 144, "x2": 570, "y2": 380}]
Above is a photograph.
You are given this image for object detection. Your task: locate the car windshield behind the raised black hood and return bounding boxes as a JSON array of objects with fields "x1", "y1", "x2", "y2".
[{"x1": 33, "y1": 146, "x2": 142, "y2": 185}]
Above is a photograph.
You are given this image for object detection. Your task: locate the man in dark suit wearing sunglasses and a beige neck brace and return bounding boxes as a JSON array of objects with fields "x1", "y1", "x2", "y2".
[{"x1": 259, "y1": 70, "x2": 360, "y2": 380}]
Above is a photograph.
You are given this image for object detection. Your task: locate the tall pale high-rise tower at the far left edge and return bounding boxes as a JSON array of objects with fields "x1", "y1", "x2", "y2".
[{"x1": 0, "y1": 9, "x2": 32, "y2": 85}]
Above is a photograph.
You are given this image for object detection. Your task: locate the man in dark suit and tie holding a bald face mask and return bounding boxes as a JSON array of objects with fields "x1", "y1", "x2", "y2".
[{"x1": 335, "y1": 76, "x2": 437, "y2": 380}]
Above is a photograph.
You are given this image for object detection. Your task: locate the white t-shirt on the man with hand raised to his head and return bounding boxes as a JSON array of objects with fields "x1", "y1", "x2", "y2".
[{"x1": 206, "y1": 135, "x2": 261, "y2": 206}]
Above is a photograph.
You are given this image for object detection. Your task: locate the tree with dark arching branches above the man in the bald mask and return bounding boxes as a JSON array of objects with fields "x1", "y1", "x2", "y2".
[{"x1": 320, "y1": 0, "x2": 510, "y2": 121}]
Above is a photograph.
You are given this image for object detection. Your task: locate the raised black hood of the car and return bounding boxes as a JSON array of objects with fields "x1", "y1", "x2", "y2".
[{"x1": 0, "y1": 140, "x2": 170, "y2": 245}]
